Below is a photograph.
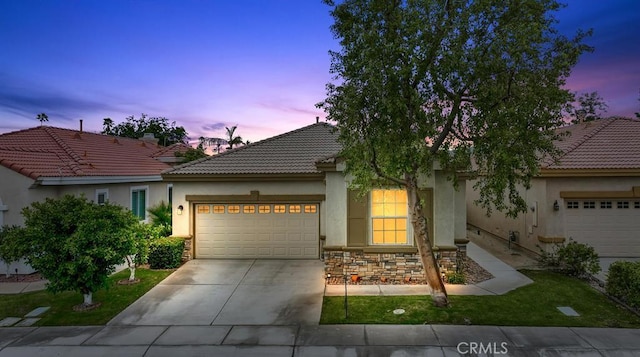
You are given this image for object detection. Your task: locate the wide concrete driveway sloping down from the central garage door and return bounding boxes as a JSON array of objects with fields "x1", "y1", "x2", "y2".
[{"x1": 108, "y1": 259, "x2": 324, "y2": 326}]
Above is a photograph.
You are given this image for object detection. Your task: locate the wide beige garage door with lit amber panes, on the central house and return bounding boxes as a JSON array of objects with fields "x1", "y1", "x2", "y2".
[{"x1": 195, "y1": 203, "x2": 319, "y2": 259}]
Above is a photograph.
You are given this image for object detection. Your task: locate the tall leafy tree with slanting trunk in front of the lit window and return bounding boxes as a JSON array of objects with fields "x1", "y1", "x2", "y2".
[{"x1": 318, "y1": 0, "x2": 589, "y2": 306}]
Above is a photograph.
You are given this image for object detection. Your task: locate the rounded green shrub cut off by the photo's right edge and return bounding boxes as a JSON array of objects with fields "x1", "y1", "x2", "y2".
[{"x1": 605, "y1": 261, "x2": 640, "y2": 308}]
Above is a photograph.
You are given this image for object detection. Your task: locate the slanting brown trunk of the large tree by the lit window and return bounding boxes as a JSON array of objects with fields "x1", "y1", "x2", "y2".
[{"x1": 405, "y1": 174, "x2": 449, "y2": 307}]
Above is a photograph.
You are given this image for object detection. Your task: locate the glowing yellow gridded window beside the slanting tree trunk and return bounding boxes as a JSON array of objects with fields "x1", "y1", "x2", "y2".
[{"x1": 371, "y1": 190, "x2": 407, "y2": 244}]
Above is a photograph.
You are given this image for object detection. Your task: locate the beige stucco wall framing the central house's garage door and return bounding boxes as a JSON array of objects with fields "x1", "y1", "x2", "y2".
[{"x1": 173, "y1": 181, "x2": 327, "y2": 236}]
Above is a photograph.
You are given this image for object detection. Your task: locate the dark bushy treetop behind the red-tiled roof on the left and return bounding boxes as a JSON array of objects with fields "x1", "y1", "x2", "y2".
[{"x1": 102, "y1": 114, "x2": 188, "y2": 146}]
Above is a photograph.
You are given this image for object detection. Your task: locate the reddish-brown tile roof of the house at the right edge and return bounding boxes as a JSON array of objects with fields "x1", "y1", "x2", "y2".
[{"x1": 543, "y1": 117, "x2": 640, "y2": 170}]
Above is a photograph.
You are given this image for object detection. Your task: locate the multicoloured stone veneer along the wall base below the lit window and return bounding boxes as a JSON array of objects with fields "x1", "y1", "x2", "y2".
[{"x1": 323, "y1": 249, "x2": 464, "y2": 284}]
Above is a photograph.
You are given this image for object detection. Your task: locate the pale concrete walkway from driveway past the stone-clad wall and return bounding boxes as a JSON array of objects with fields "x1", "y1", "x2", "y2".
[{"x1": 324, "y1": 242, "x2": 533, "y2": 296}]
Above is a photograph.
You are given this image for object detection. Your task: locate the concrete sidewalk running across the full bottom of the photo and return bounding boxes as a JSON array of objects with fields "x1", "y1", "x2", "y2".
[{"x1": 0, "y1": 325, "x2": 640, "y2": 357}]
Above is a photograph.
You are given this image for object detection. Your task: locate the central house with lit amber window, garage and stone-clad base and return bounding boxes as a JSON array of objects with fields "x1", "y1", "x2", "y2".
[{"x1": 162, "y1": 123, "x2": 466, "y2": 281}]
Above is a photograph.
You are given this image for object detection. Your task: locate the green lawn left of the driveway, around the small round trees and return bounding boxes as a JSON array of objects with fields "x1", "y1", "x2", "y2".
[{"x1": 0, "y1": 269, "x2": 173, "y2": 326}]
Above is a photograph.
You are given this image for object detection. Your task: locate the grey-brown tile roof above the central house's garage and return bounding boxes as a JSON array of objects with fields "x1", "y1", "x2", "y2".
[{"x1": 165, "y1": 123, "x2": 341, "y2": 175}]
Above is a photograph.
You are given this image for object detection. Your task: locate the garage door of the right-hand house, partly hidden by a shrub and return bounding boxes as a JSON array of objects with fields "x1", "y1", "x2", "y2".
[{"x1": 565, "y1": 200, "x2": 640, "y2": 257}]
